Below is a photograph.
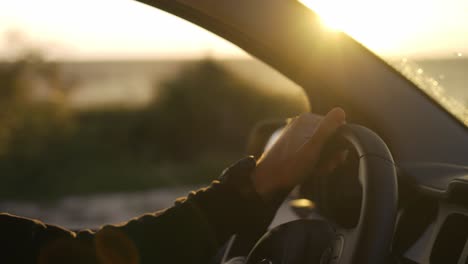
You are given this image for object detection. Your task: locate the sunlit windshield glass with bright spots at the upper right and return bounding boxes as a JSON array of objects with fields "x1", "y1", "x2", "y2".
[{"x1": 300, "y1": 0, "x2": 468, "y2": 126}]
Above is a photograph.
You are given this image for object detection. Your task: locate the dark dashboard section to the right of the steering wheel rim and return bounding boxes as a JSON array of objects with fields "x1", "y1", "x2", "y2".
[{"x1": 393, "y1": 164, "x2": 468, "y2": 264}]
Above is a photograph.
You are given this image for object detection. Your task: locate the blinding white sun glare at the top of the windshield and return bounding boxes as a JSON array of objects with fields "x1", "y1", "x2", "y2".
[{"x1": 299, "y1": 0, "x2": 435, "y2": 53}]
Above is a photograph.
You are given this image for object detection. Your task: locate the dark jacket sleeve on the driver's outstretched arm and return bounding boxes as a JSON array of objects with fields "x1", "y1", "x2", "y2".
[{"x1": 0, "y1": 158, "x2": 275, "y2": 263}]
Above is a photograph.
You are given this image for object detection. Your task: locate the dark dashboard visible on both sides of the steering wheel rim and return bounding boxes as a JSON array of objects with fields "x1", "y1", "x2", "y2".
[{"x1": 288, "y1": 153, "x2": 468, "y2": 264}]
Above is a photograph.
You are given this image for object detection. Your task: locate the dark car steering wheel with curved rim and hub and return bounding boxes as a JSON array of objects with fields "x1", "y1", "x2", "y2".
[{"x1": 221, "y1": 124, "x2": 398, "y2": 264}]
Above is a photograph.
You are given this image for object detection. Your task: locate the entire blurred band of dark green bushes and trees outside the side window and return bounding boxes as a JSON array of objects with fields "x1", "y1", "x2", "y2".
[{"x1": 0, "y1": 56, "x2": 307, "y2": 199}]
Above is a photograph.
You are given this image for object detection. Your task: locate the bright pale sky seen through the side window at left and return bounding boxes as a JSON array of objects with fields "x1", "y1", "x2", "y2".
[{"x1": 0, "y1": 0, "x2": 247, "y2": 60}]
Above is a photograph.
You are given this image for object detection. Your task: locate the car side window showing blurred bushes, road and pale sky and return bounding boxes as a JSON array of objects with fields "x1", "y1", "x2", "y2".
[{"x1": 0, "y1": 0, "x2": 308, "y2": 229}]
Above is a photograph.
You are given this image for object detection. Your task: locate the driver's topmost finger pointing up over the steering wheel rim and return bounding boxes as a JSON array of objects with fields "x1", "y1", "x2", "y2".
[{"x1": 297, "y1": 108, "x2": 346, "y2": 160}]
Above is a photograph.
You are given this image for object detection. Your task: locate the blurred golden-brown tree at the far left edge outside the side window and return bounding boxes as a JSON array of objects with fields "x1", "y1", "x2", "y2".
[{"x1": 0, "y1": 53, "x2": 72, "y2": 158}]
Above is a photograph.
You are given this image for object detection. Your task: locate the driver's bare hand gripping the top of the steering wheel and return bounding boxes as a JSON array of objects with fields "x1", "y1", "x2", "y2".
[{"x1": 252, "y1": 108, "x2": 345, "y2": 201}]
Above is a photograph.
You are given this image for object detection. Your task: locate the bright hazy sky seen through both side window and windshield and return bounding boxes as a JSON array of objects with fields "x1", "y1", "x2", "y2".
[{"x1": 0, "y1": 0, "x2": 468, "y2": 60}]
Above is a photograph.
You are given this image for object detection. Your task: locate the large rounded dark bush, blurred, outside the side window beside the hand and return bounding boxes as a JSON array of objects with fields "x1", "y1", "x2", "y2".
[{"x1": 143, "y1": 59, "x2": 307, "y2": 159}]
